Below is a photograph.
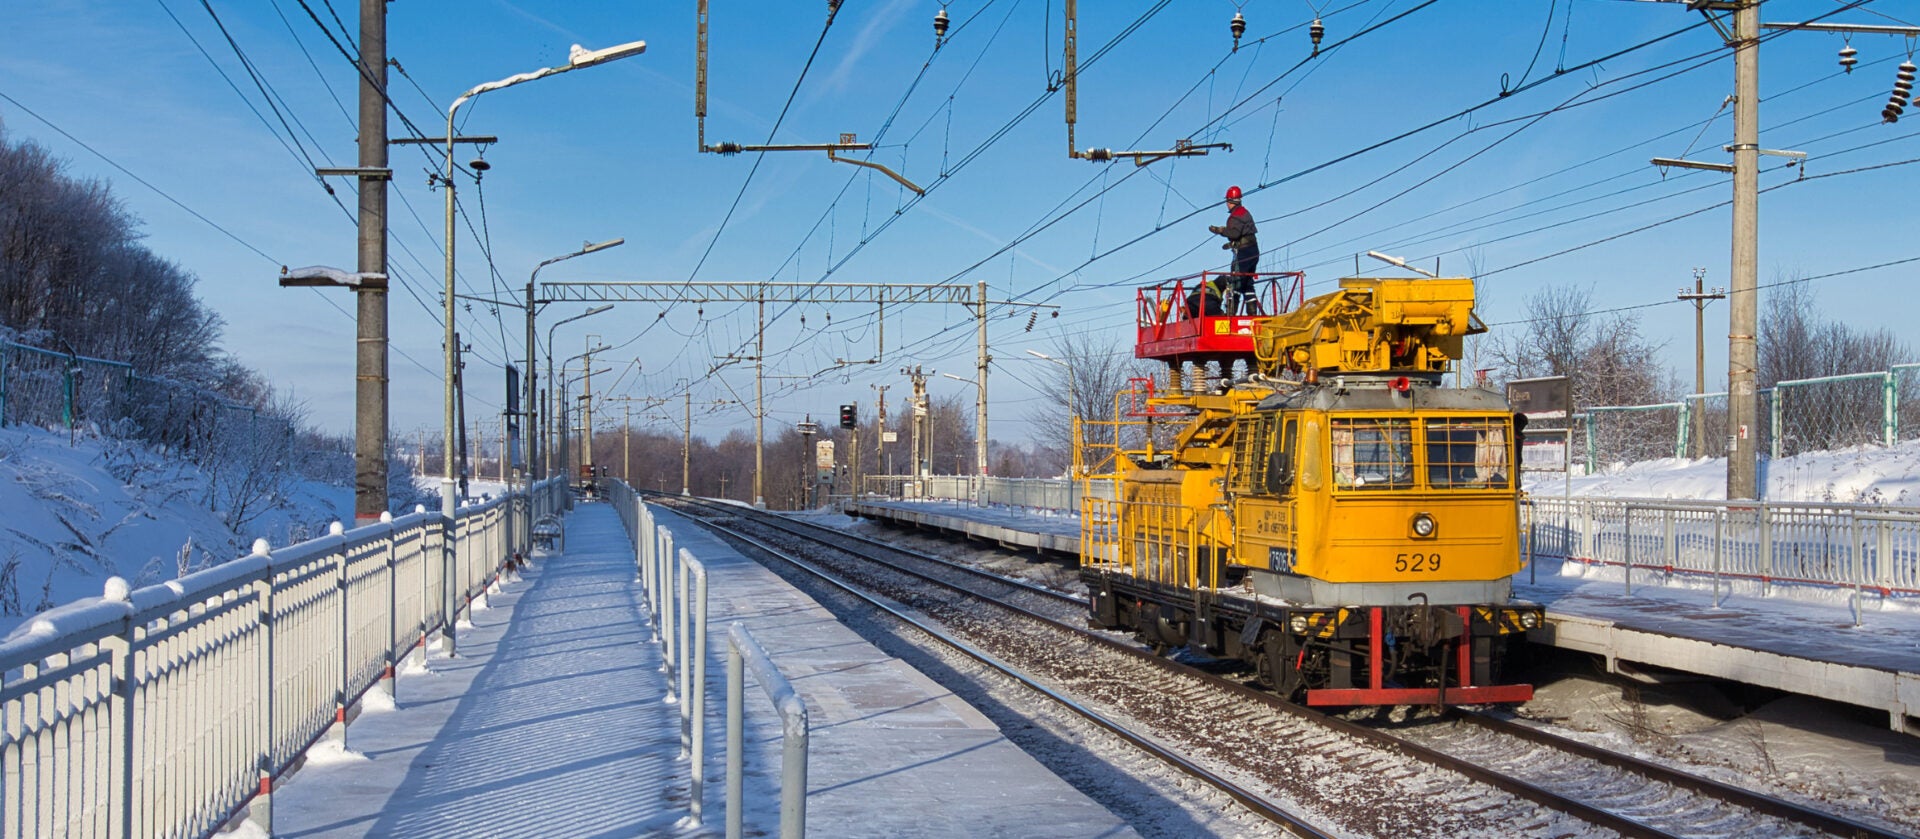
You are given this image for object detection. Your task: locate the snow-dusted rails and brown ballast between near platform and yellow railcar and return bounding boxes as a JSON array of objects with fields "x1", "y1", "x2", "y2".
[{"x1": 659, "y1": 497, "x2": 1903, "y2": 837}]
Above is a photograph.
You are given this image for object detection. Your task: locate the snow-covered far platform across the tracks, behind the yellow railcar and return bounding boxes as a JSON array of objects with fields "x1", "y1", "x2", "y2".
[{"x1": 849, "y1": 499, "x2": 1920, "y2": 733}]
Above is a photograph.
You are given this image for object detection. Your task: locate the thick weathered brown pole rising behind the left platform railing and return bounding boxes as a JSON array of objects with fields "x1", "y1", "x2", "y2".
[{"x1": 353, "y1": 0, "x2": 388, "y2": 526}]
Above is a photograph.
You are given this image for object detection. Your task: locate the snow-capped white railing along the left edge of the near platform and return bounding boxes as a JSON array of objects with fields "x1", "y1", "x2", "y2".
[{"x1": 0, "y1": 480, "x2": 566, "y2": 837}]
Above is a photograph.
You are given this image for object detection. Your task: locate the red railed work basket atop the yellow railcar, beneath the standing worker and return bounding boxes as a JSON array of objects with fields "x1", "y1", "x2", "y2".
[{"x1": 1133, "y1": 271, "x2": 1306, "y2": 365}]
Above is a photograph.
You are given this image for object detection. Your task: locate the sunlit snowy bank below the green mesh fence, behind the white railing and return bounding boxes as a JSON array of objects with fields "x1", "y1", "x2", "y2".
[{"x1": 1526, "y1": 440, "x2": 1920, "y2": 507}]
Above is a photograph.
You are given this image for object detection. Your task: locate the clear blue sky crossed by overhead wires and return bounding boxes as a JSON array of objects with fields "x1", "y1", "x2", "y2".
[{"x1": 0, "y1": 0, "x2": 1920, "y2": 440}]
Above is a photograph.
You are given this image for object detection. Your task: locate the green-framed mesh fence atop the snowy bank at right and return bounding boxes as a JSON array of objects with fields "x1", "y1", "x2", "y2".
[{"x1": 1574, "y1": 365, "x2": 1920, "y2": 472}]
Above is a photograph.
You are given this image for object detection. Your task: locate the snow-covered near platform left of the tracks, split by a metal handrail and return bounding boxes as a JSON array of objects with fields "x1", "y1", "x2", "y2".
[{"x1": 273, "y1": 503, "x2": 1135, "y2": 837}]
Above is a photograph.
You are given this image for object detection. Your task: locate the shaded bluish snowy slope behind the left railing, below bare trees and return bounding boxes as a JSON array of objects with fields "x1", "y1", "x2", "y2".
[{"x1": 0, "y1": 426, "x2": 353, "y2": 635}]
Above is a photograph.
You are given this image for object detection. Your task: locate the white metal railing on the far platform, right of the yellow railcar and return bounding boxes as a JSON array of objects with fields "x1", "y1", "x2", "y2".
[{"x1": 1526, "y1": 497, "x2": 1920, "y2": 620}]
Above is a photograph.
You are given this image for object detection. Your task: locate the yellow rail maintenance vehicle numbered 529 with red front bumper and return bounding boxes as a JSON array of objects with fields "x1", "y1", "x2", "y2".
[{"x1": 1081, "y1": 275, "x2": 1542, "y2": 705}]
